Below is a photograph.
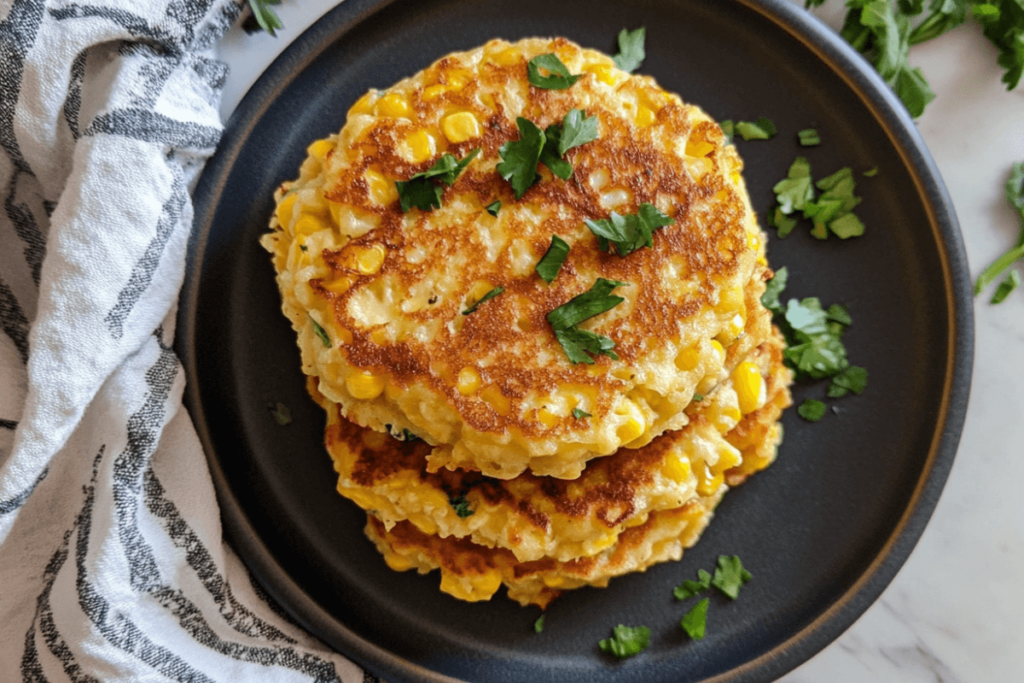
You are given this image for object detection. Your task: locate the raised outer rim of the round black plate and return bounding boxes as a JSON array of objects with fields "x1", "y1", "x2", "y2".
[{"x1": 174, "y1": 0, "x2": 974, "y2": 683}]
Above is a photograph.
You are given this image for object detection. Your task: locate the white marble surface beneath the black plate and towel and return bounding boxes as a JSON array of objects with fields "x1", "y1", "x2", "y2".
[{"x1": 214, "y1": 0, "x2": 1024, "y2": 683}]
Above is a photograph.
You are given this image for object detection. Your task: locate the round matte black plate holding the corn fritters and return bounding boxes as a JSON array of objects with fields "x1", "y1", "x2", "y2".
[{"x1": 178, "y1": 0, "x2": 973, "y2": 683}]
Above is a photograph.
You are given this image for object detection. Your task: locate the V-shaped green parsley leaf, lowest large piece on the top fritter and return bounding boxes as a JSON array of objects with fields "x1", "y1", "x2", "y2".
[{"x1": 548, "y1": 278, "x2": 628, "y2": 365}]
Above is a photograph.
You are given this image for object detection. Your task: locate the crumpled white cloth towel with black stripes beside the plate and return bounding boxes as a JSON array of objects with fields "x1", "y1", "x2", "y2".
[{"x1": 0, "y1": 0, "x2": 375, "y2": 683}]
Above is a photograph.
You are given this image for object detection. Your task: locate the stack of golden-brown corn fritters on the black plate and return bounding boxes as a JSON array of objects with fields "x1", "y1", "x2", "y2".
[{"x1": 262, "y1": 39, "x2": 792, "y2": 606}]
